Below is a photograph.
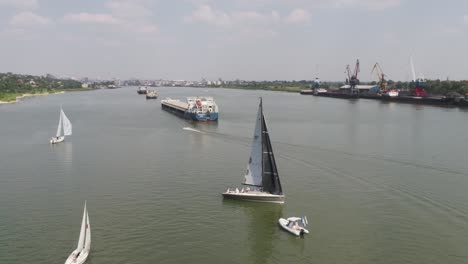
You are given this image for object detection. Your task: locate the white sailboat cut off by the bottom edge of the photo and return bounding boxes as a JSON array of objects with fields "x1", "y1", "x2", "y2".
[{"x1": 65, "y1": 202, "x2": 91, "y2": 264}]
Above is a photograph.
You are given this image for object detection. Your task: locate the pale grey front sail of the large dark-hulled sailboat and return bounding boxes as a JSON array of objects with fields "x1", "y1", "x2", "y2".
[{"x1": 243, "y1": 100, "x2": 263, "y2": 187}]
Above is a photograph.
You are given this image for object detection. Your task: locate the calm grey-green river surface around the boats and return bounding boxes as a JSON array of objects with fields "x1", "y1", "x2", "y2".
[{"x1": 0, "y1": 87, "x2": 468, "y2": 264}]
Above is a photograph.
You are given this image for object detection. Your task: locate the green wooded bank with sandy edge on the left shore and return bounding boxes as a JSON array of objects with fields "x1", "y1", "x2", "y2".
[{"x1": 0, "y1": 72, "x2": 94, "y2": 104}]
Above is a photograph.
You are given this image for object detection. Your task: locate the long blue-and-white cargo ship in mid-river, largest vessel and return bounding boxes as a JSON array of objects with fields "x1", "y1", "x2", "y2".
[{"x1": 161, "y1": 96, "x2": 219, "y2": 121}]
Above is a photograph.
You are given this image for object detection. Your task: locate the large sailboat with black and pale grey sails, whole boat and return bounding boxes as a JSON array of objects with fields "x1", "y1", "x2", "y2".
[{"x1": 223, "y1": 98, "x2": 285, "y2": 203}]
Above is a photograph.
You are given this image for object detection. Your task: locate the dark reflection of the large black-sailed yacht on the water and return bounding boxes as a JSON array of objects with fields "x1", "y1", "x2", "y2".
[{"x1": 223, "y1": 199, "x2": 283, "y2": 264}]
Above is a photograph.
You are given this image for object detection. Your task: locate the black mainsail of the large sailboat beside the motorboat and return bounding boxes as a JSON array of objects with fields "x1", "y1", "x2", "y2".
[{"x1": 260, "y1": 99, "x2": 283, "y2": 195}]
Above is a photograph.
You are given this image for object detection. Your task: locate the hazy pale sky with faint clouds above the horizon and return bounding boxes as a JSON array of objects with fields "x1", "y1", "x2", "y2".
[{"x1": 0, "y1": 0, "x2": 468, "y2": 81}]
